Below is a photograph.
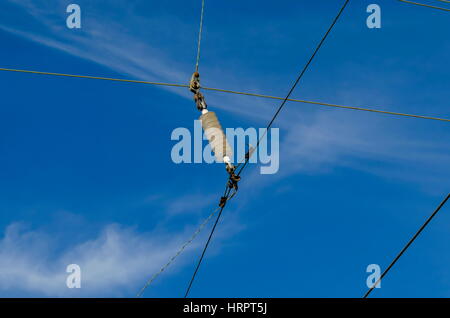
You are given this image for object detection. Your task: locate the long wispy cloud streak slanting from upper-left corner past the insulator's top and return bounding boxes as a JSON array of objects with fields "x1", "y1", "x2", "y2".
[{"x1": 0, "y1": 0, "x2": 282, "y2": 122}]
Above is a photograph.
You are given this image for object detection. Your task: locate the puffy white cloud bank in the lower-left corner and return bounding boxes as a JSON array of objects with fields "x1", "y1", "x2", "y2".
[{"x1": 0, "y1": 223, "x2": 212, "y2": 297}]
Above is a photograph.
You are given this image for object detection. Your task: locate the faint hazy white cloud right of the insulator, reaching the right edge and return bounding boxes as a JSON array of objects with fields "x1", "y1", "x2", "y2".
[{"x1": 241, "y1": 108, "x2": 450, "y2": 193}]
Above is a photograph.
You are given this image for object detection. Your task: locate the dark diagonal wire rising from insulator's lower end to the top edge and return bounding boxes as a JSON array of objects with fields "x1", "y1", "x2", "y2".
[{"x1": 237, "y1": 0, "x2": 350, "y2": 176}]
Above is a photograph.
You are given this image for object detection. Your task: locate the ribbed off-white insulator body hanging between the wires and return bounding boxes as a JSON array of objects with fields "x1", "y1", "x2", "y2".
[{"x1": 200, "y1": 112, "x2": 233, "y2": 162}]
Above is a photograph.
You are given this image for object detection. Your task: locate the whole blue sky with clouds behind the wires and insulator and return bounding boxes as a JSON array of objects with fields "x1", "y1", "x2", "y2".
[{"x1": 0, "y1": 0, "x2": 450, "y2": 297}]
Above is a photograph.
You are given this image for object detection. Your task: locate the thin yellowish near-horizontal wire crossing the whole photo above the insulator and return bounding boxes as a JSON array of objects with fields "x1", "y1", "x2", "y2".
[{"x1": 0, "y1": 68, "x2": 450, "y2": 122}]
